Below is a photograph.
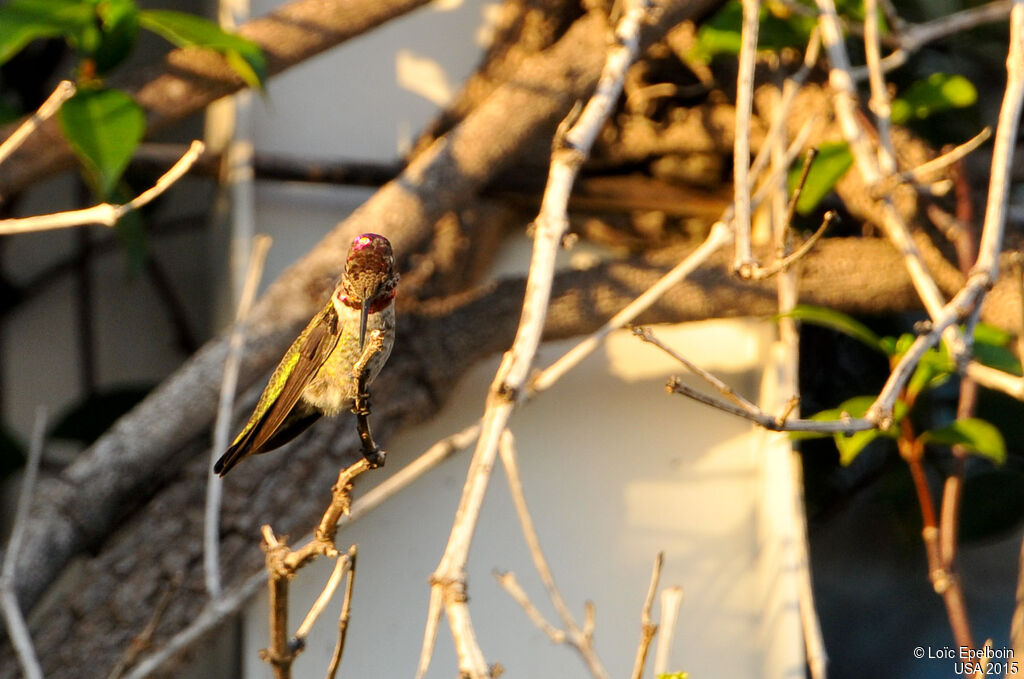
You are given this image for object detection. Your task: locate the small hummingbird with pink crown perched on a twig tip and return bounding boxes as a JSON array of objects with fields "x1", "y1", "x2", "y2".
[{"x1": 213, "y1": 234, "x2": 398, "y2": 476}]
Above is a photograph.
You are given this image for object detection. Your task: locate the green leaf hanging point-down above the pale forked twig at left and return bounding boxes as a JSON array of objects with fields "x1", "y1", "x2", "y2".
[{"x1": 57, "y1": 89, "x2": 145, "y2": 200}]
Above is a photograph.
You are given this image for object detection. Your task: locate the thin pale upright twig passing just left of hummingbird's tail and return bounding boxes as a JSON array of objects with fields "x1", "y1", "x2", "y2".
[{"x1": 203, "y1": 236, "x2": 271, "y2": 598}]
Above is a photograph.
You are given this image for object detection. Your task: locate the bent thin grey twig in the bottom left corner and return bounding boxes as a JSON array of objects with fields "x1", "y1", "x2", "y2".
[{"x1": 0, "y1": 407, "x2": 46, "y2": 679}]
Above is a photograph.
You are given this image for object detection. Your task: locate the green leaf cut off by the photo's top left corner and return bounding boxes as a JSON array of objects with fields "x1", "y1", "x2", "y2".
[{"x1": 0, "y1": 0, "x2": 94, "y2": 65}]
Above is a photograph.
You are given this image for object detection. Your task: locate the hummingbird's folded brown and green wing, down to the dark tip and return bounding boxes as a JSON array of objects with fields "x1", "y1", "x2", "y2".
[{"x1": 213, "y1": 303, "x2": 340, "y2": 476}]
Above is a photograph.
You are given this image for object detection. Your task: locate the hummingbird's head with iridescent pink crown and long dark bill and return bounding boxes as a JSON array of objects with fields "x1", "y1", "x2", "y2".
[{"x1": 334, "y1": 234, "x2": 398, "y2": 349}]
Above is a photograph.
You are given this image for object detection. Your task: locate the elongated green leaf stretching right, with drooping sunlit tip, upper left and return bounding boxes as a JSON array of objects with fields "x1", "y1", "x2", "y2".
[{"x1": 138, "y1": 9, "x2": 266, "y2": 89}]
